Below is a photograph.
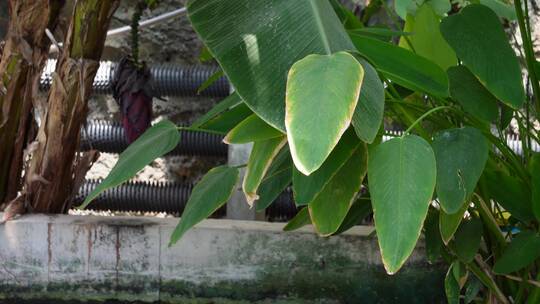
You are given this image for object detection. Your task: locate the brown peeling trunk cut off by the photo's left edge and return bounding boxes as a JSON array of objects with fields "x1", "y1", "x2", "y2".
[{"x1": 0, "y1": 0, "x2": 64, "y2": 203}]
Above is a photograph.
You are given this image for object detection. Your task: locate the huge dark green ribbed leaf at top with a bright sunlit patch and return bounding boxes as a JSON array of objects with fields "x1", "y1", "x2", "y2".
[{"x1": 187, "y1": 0, "x2": 354, "y2": 131}]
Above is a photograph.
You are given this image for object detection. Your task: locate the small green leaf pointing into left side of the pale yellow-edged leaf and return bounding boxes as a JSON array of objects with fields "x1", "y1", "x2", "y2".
[{"x1": 223, "y1": 114, "x2": 283, "y2": 144}]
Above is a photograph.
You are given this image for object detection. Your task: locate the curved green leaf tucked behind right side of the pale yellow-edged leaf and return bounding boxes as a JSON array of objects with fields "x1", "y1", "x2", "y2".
[{"x1": 351, "y1": 58, "x2": 384, "y2": 144}]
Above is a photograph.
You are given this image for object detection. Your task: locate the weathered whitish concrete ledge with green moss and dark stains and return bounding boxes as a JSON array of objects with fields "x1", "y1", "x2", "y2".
[{"x1": 0, "y1": 214, "x2": 444, "y2": 303}]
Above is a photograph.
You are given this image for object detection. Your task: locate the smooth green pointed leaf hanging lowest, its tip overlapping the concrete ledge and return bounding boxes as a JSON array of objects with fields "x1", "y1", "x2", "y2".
[{"x1": 368, "y1": 135, "x2": 437, "y2": 274}]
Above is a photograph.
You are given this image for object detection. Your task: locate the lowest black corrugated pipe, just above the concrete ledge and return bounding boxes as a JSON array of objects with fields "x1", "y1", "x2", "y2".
[{"x1": 74, "y1": 180, "x2": 297, "y2": 222}]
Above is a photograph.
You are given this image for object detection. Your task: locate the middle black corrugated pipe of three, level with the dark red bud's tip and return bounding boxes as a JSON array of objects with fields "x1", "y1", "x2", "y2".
[{"x1": 81, "y1": 120, "x2": 228, "y2": 157}]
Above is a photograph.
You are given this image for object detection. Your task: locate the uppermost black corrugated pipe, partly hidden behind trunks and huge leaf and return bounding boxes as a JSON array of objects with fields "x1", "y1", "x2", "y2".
[{"x1": 40, "y1": 59, "x2": 230, "y2": 97}]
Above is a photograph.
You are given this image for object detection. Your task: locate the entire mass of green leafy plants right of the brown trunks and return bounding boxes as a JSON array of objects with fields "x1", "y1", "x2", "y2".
[{"x1": 87, "y1": 0, "x2": 540, "y2": 303}]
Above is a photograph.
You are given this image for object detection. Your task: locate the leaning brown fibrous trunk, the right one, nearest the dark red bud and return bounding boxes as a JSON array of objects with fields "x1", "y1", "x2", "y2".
[{"x1": 25, "y1": 0, "x2": 120, "y2": 213}]
